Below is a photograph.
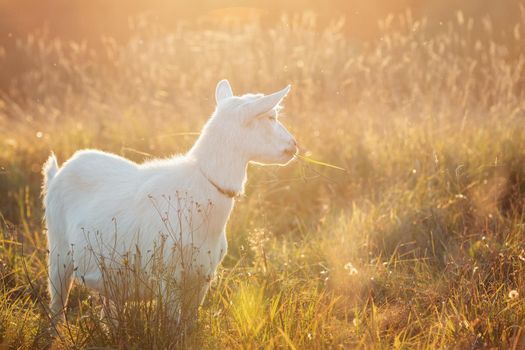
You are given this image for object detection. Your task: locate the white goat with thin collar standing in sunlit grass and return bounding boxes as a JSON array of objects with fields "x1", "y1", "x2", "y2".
[{"x1": 43, "y1": 80, "x2": 297, "y2": 322}]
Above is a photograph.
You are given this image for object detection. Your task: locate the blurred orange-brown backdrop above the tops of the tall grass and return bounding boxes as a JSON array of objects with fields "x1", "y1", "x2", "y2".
[{"x1": 0, "y1": 0, "x2": 520, "y2": 88}]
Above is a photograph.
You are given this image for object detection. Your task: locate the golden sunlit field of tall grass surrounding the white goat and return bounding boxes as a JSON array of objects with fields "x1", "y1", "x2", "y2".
[{"x1": 0, "y1": 7, "x2": 525, "y2": 349}]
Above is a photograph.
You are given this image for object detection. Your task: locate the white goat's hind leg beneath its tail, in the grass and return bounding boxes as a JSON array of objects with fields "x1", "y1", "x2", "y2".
[{"x1": 48, "y1": 243, "x2": 73, "y2": 326}]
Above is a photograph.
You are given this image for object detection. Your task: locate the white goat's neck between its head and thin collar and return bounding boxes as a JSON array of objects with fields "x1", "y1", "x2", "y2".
[{"x1": 188, "y1": 134, "x2": 248, "y2": 194}]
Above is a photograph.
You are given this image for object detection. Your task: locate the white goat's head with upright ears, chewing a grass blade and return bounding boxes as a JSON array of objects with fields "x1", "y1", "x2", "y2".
[{"x1": 213, "y1": 80, "x2": 297, "y2": 165}]
